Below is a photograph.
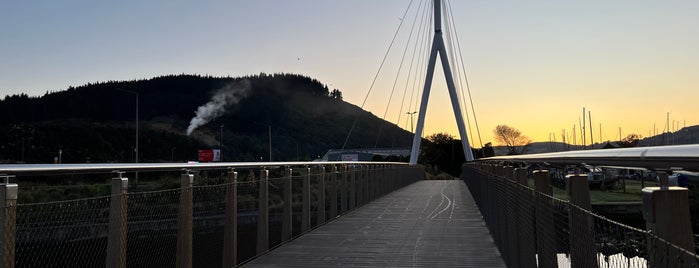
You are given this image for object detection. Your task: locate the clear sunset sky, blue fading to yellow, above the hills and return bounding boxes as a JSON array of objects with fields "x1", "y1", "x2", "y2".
[{"x1": 0, "y1": 0, "x2": 699, "y2": 147}]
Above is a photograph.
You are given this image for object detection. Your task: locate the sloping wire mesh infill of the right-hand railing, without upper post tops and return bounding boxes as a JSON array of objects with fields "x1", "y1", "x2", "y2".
[{"x1": 463, "y1": 164, "x2": 699, "y2": 267}]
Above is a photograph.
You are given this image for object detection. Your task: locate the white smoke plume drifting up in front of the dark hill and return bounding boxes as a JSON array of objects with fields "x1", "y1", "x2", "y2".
[{"x1": 187, "y1": 80, "x2": 250, "y2": 136}]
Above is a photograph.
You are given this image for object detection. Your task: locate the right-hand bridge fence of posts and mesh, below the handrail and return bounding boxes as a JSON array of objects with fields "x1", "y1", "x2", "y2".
[{"x1": 462, "y1": 162, "x2": 699, "y2": 267}]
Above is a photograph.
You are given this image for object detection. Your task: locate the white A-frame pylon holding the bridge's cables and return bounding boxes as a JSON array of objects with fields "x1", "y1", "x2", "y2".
[{"x1": 410, "y1": 0, "x2": 473, "y2": 165}]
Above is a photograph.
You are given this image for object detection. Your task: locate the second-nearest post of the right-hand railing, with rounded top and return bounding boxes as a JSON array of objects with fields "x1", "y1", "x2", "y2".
[{"x1": 568, "y1": 174, "x2": 597, "y2": 268}]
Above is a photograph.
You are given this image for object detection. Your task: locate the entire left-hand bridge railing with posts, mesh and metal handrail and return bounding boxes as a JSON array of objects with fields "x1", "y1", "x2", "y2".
[{"x1": 0, "y1": 162, "x2": 424, "y2": 267}]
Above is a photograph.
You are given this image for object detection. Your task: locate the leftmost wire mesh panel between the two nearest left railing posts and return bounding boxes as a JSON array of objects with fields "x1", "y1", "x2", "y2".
[{"x1": 15, "y1": 197, "x2": 110, "y2": 267}]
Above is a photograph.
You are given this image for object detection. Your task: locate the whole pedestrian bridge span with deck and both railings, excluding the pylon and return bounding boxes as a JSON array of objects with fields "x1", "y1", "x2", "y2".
[{"x1": 0, "y1": 146, "x2": 699, "y2": 267}]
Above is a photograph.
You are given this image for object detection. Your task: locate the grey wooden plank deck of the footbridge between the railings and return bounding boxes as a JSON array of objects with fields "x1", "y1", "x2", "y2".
[{"x1": 244, "y1": 180, "x2": 505, "y2": 267}]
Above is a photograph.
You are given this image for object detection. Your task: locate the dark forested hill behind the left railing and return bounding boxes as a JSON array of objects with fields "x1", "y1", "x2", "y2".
[{"x1": 0, "y1": 74, "x2": 411, "y2": 163}]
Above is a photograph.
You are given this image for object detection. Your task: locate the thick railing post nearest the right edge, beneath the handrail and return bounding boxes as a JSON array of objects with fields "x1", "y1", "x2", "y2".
[{"x1": 643, "y1": 172, "x2": 694, "y2": 267}]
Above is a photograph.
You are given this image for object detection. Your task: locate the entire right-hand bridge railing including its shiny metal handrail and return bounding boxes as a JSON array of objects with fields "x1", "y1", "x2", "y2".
[{"x1": 462, "y1": 146, "x2": 699, "y2": 267}]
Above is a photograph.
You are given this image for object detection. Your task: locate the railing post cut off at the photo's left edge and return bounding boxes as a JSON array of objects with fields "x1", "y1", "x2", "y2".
[{"x1": 0, "y1": 176, "x2": 18, "y2": 268}]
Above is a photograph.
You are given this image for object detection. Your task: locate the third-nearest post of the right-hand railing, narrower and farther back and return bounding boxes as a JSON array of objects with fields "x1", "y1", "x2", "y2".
[{"x1": 534, "y1": 170, "x2": 558, "y2": 268}]
